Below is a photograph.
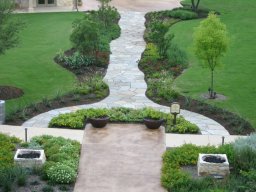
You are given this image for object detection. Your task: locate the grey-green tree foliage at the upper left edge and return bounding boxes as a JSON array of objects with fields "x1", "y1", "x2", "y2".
[{"x1": 0, "y1": 0, "x2": 23, "y2": 55}]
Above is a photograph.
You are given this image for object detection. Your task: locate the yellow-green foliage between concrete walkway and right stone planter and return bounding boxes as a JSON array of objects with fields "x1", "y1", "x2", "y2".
[{"x1": 161, "y1": 144, "x2": 234, "y2": 192}]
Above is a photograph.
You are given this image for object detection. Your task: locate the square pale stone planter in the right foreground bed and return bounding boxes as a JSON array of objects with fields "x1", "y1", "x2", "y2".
[{"x1": 197, "y1": 154, "x2": 230, "y2": 178}]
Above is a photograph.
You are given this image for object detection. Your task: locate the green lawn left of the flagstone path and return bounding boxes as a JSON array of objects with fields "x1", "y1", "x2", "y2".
[{"x1": 0, "y1": 13, "x2": 81, "y2": 116}]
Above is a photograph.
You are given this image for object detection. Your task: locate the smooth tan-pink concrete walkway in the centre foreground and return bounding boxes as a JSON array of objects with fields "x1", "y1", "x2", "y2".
[{"x1": 74, "y1": 124, "x2": 165, "y2": 192}]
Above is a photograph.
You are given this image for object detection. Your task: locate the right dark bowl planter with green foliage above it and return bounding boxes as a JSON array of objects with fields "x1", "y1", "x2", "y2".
[{"x1": 144, "y1": 108, "x2": 164, "y2": 129}]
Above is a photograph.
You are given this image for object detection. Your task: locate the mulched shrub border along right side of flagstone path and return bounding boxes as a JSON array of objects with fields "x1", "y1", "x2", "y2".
[{"x1": 139, "y1": 8, "x2": 255, "y2": 135}]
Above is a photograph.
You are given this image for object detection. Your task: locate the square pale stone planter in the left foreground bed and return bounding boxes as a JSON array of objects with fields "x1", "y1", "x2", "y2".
[{"x1": 14, "y1": 149, "x2": 46, "y2": 167}]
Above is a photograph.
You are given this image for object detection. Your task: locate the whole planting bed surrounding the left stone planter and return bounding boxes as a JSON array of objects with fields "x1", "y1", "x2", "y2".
[{"x1": 0, "y1": 134, "x2": 80, "y2": 192}]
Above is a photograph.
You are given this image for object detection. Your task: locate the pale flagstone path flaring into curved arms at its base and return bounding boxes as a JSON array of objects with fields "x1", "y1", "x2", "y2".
[{"x1": 23, "y1": 11, "x2": 229, "y2": 135}]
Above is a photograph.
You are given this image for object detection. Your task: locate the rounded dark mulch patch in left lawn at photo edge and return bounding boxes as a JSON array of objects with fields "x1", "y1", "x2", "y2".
[{"x1": 0, "y1": 86, "x2": 24, "y2": 100}]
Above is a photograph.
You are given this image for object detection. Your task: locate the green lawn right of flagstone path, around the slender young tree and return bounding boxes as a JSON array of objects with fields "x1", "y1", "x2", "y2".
[{"x1": 171, "y1": 0, "x2": 256, "y2": 127}]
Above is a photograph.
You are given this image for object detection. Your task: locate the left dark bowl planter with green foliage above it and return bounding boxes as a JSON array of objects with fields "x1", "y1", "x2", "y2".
[{"x1": 86, "y1": 109, "x2": 109, "y2": 128}]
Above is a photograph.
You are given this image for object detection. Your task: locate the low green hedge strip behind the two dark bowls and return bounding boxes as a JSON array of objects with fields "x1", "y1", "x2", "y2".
[{"x1": 49, "y1": 107, "x2": 199, "y2": 133}]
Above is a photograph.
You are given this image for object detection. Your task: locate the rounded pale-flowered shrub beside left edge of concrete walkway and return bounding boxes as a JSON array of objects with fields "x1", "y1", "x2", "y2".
[{"x1": 47, "y1": 163, "x2": 76, "y2": 184}]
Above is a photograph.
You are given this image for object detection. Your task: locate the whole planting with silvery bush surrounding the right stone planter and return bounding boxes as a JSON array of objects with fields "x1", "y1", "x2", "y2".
[{"x1": 161, "y1": 135, "x2": 256, "y2": 192}]
